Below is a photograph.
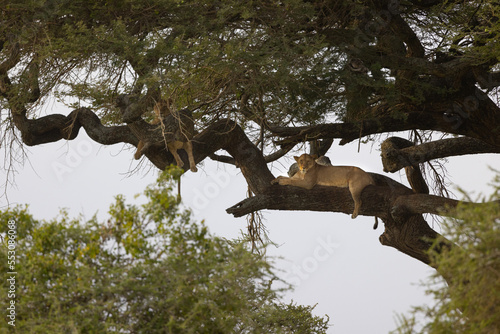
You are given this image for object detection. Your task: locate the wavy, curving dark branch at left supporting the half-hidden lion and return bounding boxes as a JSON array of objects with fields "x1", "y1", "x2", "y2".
[{"x1": 9, "y1": 108, "x2": 273, "y2": 194}]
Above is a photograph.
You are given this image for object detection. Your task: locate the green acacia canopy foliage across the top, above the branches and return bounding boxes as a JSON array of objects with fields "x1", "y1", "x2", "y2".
[{"x1": 0, "y1": 0, "x2": 500, "y2": 132}]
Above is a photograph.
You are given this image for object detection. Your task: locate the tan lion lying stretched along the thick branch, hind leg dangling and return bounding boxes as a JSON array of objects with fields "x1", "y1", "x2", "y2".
[{"x1": 271, "y1": 154, "x2": 375, "y2": 218}]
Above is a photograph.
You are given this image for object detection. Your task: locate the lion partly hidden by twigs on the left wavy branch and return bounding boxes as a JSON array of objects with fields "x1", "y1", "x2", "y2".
[{"x1": 134, "y1": 103, "x2": 198, "y2": 172}]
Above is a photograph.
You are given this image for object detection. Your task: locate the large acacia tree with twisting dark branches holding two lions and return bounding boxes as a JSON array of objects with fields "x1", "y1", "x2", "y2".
[{"x1": 0, "y1": 0, "x2": 500, "y2": 276}]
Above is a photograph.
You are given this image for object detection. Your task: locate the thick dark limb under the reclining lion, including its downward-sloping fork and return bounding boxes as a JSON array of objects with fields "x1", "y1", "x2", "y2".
[{"x1": 226, "y1": 174, "x2": 460, "y2": 264}]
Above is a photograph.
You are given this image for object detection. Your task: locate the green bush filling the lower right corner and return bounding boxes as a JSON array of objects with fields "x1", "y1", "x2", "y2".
[{"x1": 390, "y1": 180, "x2": 500, "y2": 334}]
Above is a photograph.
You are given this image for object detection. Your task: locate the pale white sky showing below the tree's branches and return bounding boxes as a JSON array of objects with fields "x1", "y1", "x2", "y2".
[{"x1": 0, "y1": 124, "x2": 500, "y2": 334}]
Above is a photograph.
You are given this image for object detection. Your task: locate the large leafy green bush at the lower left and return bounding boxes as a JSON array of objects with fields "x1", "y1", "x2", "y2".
[{"x1": 0, "y1": 173, "x2": 327, "y2": 333}]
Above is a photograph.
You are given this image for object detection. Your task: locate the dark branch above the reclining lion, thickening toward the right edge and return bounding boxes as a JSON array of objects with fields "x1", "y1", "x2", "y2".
[{"x1": 269, "y1": 89, "x2": 500, "y2": 147}]
